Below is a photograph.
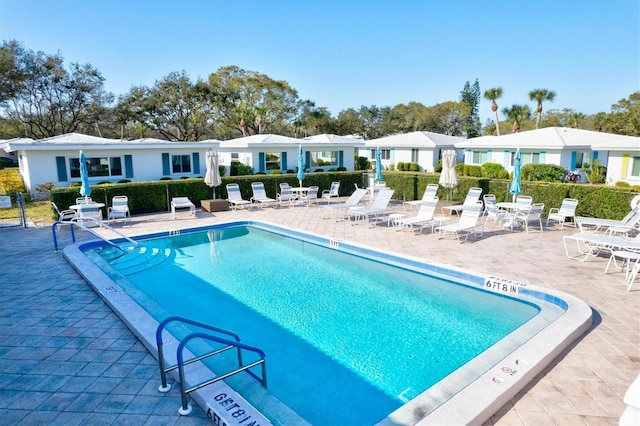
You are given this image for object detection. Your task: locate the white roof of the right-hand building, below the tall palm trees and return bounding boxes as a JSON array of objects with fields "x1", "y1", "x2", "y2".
[{"x1": 456, "y1": 127, "x2": 632, "y2": 149}]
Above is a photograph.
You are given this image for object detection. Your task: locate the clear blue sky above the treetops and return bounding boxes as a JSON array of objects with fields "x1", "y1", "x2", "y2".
[{"x1": 0, "y1": 0, "x2": 640, "y2": 124}]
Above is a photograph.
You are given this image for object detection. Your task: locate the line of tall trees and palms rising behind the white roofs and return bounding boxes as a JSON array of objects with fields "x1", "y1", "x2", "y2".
[{"x1": 0, "y1": 40, "x2": 640, "y2": 141}]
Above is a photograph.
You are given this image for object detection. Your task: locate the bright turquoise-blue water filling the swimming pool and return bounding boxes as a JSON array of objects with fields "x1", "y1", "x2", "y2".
[{"x1": 89, "y1": 226, "x2": 552, "y2": 425}]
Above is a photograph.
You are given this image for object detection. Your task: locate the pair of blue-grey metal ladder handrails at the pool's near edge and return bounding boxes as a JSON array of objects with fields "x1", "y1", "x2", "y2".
[{"x1": 156, "y1": 316, "x2": 267, "y2": 416}]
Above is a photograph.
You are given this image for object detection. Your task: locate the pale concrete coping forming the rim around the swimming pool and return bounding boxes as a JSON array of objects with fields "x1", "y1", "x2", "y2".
[{"x1": 64, "y1": 221, "x2": 592, "y2": 425}]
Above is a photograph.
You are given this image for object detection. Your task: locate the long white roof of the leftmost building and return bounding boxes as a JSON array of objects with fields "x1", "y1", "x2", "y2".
[{"x1": 5, "y1": 133, "x2": 219, "y2": 151}]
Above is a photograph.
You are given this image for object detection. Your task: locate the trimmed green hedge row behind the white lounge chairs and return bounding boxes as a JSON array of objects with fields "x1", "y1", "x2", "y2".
[{"x1": 51, "y1": 171, "x2": 638, "y2": 219}]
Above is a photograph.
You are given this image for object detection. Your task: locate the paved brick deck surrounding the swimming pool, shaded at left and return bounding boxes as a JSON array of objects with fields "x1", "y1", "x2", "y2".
[{"x1": 0, "y1": 201, "x2": 640, "y2": 425}]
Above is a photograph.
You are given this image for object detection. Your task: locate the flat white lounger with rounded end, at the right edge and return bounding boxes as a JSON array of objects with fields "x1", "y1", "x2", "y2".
[{"x1": 562, "y1": 232, "x2": 640, "y2": 261}]
